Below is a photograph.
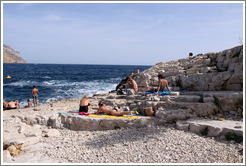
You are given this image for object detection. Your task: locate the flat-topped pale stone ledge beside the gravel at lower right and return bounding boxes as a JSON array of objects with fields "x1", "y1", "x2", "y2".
[{"x1": 176, "y1": 119, "x2": 243, "y2": 139}]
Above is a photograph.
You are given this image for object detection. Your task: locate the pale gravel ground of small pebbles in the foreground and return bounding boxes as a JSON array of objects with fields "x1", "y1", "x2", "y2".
[{"x1": 40, "y1": 125, "x2": 243, "y2": 163}]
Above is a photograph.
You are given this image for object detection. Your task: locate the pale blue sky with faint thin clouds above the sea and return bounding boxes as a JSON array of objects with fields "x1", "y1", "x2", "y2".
[{"x1": 3, "y1": 3, "x2": 243, "y2": 65}]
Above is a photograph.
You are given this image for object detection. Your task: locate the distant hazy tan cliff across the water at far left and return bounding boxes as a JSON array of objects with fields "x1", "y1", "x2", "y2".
[{"x1": 3, "y1": 44, "x2": 26, "y2": 63}]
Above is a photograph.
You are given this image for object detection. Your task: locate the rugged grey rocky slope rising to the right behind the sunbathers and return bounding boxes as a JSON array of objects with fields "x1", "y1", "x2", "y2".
[{"x1": 117, "y1": 46, "x2": 243, "y2": 91}]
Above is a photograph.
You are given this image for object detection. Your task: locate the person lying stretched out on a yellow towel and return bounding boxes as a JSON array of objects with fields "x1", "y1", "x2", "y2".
[{"x1": 95, "y1": 102, "x2": 133, "y2": 116}]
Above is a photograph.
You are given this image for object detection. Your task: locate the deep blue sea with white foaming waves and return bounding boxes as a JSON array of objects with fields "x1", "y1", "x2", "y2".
[{"x1": 3, "y1": 63, "x2": 151, "y2": 107}]
